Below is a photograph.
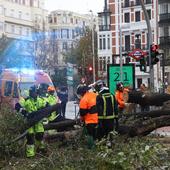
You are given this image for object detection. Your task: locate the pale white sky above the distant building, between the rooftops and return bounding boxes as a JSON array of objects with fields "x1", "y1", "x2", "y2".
[{"x1": 45, "y1": 0, "x2": 104, "y2": 14}]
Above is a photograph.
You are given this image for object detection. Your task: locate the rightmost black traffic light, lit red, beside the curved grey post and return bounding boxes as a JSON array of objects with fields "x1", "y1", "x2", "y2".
[{"x1": 150, "y1": 44, "x2": 159, "y2": 65}]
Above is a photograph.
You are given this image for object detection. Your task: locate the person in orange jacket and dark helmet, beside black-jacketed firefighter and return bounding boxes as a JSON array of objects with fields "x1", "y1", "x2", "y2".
[{"x1": 77, "y1": 85, "x2": 98, "y2": 148}]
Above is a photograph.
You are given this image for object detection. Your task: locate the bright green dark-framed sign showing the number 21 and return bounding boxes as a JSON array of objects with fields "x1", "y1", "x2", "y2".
[{"x1": 107, "y1": 64, "x2": 135, "y2": 94}]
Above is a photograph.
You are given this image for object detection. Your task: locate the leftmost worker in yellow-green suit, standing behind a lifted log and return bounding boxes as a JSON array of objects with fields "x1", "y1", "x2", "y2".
[{"x1": 22, "y1": 86, "x2": 45, "y2": 157}]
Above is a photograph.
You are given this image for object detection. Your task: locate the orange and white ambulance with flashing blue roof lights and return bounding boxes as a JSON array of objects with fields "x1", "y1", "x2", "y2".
[{"x1": 0, "y1": 69, "x2": 56, "y2": 107}]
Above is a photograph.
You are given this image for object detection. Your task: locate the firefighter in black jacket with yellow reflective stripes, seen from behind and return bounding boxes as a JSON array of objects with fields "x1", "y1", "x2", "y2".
[{"x1": 95, "y1": 80, "x2": 118, "y2": 140}]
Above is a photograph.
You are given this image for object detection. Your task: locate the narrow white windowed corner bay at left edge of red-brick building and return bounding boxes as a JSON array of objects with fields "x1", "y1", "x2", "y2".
[{"x1": 97, "y1": 0, "x2": 112, "y2": 78}]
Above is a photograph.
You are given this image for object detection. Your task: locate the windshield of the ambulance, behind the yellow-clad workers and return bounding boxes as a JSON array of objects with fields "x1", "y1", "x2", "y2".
[{"x1": 19, "y1": 82, "x2": 35, "y2": 98}]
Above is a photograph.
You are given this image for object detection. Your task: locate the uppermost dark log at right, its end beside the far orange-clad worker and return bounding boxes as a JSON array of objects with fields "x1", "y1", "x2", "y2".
[{"x1": 126, "y1": 91, "x2": 170, "y2": 106}]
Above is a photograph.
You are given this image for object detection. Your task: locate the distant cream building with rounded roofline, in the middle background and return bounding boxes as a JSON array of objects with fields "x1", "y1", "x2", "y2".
[{"x1": 49, "y1": 10, "x2": 93, "y2": 66}]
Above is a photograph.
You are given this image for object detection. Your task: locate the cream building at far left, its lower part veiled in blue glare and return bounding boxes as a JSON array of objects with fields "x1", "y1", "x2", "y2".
[{"x1": 0, "y1": 0, "x2": 48, "y2": 67}]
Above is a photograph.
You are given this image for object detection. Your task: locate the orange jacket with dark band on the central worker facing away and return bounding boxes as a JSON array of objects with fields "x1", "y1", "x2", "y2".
[{"x1": 79, "y1": 92, "x2": 98, "y2": 124}]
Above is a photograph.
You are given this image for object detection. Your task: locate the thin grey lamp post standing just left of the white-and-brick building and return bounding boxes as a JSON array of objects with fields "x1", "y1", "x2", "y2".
[{"x1": 90, "y1": 10, "x2": 96, "y2": 82}]
